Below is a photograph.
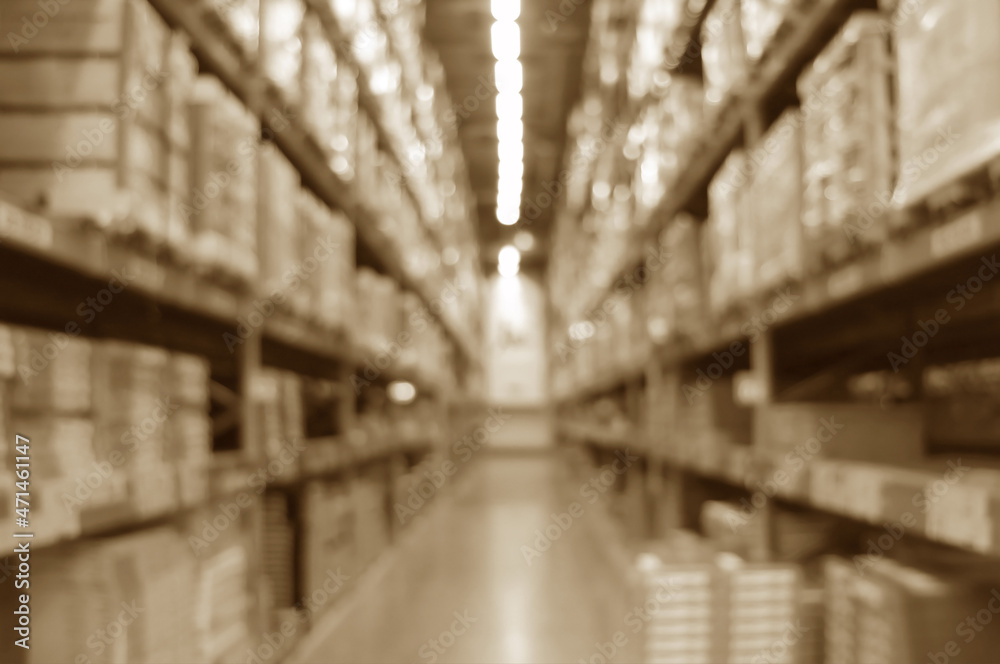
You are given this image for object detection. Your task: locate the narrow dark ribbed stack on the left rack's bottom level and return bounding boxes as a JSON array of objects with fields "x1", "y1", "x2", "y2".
[{"x1": 259, "y1": 491, "x2": 295, "y2": 629}]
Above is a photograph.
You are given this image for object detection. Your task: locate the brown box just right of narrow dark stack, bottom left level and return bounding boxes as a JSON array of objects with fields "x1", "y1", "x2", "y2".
[{"x1": 300, "y1": 482, "x2": 359, "y2": 596}]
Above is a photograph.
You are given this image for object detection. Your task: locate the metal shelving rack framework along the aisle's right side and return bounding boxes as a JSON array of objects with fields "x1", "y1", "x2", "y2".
[{"x1": 553, "y1": 0, "x2": 1000, "y2": 624}]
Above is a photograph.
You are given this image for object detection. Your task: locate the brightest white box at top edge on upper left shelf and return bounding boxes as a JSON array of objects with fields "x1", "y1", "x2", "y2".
[{"x1": 260, "y1": 0, "x2": 306, "y2": 104}]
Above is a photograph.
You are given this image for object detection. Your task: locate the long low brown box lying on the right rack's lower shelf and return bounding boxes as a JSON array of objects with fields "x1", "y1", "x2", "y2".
[{"x1": 753, "y1": 402, "x2": 925, "y2": 464}]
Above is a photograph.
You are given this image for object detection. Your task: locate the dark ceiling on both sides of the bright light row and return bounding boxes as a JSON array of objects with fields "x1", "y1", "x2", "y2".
[{"x1": 424, "y1": 0, "x2": 591, "y2": 267}]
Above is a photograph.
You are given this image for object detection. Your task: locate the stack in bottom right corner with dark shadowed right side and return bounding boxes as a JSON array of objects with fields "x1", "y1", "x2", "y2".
[{"x1": 825, "y1": 557, "x2": 1000, "y2": 664}]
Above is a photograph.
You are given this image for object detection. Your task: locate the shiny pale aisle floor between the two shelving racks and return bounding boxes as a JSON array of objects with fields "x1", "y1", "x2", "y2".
[{"x1": 305, "y1": 455, "x2": 636, "y2": 664}]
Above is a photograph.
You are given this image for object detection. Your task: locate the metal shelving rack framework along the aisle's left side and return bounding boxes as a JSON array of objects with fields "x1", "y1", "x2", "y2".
[{"x1": 0, "y1": 0, "x2": 484, "y2": 662}]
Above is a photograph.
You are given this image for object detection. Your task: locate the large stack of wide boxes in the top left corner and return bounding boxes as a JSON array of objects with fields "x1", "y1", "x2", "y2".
[{"x1": 0, "y1": 0, "x2": 171, "y2": 245}]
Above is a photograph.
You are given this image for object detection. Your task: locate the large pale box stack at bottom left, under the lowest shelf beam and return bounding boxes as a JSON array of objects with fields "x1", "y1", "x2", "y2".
[{"x1": 27, "y1": 529, "x2": 201, "y2": 664}]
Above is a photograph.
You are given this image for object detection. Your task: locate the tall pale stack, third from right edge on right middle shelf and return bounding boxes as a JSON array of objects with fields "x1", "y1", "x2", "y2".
[{"x1": 746, "y1": 110, "x2": 804, "y2": 292}]
